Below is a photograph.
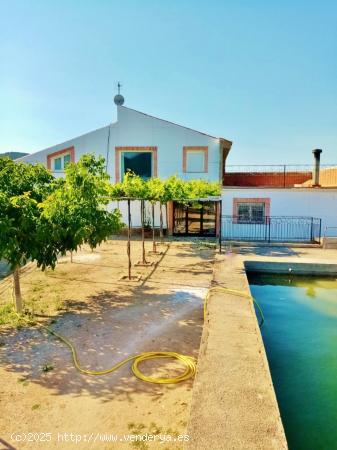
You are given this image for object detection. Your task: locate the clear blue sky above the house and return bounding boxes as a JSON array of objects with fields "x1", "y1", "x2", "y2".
[{"x1": 0, "y1": 0, "x2": 337, "y2": 164}]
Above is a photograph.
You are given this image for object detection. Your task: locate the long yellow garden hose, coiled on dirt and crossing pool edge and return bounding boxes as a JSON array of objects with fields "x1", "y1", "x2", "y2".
[{"x1": 20, "y1": 286, "x2": 264, "y2": 384}]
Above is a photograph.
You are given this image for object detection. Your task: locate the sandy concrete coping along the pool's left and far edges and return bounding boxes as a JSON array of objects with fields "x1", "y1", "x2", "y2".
[{"x1": 184, "y1": 246, "x2": 337, "y2": 450}]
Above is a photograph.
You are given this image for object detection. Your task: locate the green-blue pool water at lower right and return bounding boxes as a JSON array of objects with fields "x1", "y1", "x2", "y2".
[{"x1": 248, "y1": 273, "x2": 337, "y2": 450}]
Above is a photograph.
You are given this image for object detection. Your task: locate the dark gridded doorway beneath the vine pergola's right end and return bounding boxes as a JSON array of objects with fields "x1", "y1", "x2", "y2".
[{"x1": 173, "y1": 201, "x2": 216, "y2": 237}]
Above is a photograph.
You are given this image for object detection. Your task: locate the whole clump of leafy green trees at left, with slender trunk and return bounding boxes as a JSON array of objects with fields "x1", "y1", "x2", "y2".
[{"x1": 0, "y1": 155, "x2": 122, "y2": 312}]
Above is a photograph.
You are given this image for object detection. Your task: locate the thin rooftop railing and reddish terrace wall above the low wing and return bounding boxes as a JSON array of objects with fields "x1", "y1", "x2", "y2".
[{"x1": 223, "y1": 164, "x2": 337, "y2": 188}]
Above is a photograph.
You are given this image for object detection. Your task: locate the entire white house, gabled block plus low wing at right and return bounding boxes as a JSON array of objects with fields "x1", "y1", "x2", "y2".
[{"x1": 20, "y1": 95, "x2": 337, "y2": 241}]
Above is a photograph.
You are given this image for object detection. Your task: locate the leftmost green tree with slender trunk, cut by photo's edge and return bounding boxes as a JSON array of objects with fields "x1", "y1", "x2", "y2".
[{"x1": 0, "y1": 158, "x2": 53, "y2": 312}]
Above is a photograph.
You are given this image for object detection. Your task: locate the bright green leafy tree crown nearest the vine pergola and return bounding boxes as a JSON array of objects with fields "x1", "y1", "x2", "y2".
[{"x1": 42, "y1": 154, "x2": 122, "y2": 260}]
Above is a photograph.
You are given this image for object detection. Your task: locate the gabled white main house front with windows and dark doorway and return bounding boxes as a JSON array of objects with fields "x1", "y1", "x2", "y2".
[{"x1": 20, "y1": 105, "x2": 232, "y2": 236}]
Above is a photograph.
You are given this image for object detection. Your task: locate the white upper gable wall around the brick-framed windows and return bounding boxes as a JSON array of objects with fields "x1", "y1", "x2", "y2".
[{"x1": 20, "y1": 106, "x2": 220, "y2": 182}]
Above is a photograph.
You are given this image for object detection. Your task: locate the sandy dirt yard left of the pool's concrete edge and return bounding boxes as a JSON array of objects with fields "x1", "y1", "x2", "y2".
[{"x1": 0, "y1": 241, "x2": 214, "y2": 450}]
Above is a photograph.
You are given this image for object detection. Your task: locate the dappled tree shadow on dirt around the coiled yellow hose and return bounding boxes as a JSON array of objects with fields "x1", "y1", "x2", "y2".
[{"x1": 0, "y1": 286, "x2": 203, "y2": 403}]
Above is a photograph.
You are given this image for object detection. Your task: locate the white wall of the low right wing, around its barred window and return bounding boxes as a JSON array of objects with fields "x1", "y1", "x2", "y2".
[{"x1": 222, "y1": 188, "x2": 337, "y2": 234}]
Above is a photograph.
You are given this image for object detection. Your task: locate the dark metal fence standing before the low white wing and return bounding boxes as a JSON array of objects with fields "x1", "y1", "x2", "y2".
[{"x1": 221, "y1": 216, "x2": 322, "y2": 242}]
